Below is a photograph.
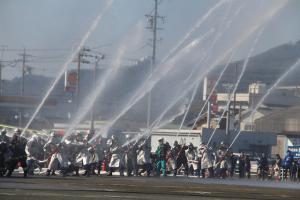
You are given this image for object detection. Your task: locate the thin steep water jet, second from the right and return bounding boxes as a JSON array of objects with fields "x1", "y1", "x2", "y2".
[{"x1": 207, "y1": 28, "x2": 264, "y2": 145}]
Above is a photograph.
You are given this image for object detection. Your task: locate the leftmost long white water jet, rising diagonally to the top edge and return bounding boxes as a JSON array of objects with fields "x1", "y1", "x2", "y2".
[{"x1": 21, "y1": 0, "x2": 114, "y2": 135}]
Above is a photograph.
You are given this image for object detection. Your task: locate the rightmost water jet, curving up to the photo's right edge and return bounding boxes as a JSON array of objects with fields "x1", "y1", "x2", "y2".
[{"x1": 228, "y1": 58, "x2": 300, "y2": 150}]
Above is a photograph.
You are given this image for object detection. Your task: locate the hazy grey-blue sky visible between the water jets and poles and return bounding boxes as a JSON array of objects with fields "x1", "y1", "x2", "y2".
[{"x1": 0, "y1": 0, "x2": 300, "y2": 79}]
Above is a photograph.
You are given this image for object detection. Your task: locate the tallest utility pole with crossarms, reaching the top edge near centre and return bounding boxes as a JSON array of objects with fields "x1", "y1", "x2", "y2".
[{"x1": 146, "y1": 0, "x2": 165, "y2": 129}]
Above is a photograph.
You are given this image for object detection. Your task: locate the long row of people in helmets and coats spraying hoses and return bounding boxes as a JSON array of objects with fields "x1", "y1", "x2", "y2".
[{"x1": 0, "y1": 129, "x2": 300, "y2": 181}]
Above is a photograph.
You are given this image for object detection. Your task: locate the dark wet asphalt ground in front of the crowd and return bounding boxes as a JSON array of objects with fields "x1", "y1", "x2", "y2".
[{"x1": 0, "y1": 176, "x2": 300, "y2": 200}]
